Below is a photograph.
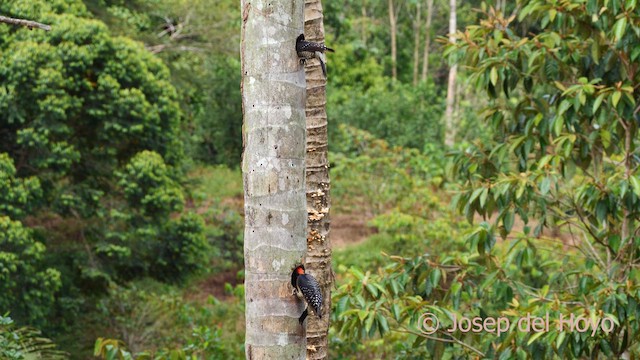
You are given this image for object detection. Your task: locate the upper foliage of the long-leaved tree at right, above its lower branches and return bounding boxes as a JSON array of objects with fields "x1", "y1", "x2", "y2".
[{"x1": 450, "y1": 1, "x2": 640, "y2": 268}]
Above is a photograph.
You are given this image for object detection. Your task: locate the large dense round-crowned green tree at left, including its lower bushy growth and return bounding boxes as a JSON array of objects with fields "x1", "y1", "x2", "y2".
[{"x1": 0, "y1": 0, "x2": 208, "y2": 320}]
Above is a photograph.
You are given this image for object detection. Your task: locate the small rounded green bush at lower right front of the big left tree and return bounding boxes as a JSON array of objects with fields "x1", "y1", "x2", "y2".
[{"x1": 102, "y1": 151, "x2": 210, "y2": 280}]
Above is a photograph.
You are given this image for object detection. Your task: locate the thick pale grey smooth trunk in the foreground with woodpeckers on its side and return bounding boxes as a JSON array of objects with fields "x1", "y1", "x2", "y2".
[{"x1": 240, "y1": 0, "x2": 307, "y2": 359}]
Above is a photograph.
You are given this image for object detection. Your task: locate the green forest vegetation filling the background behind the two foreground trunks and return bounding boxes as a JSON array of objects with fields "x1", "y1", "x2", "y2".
[{"x1": 0, "y1": 0, "x2": 640, "y2": 359}]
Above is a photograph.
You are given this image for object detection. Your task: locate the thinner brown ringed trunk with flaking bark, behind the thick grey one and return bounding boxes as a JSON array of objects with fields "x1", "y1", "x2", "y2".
[{"x1": 304, "y1": 0, "x2": 332, "y2": 359}]
